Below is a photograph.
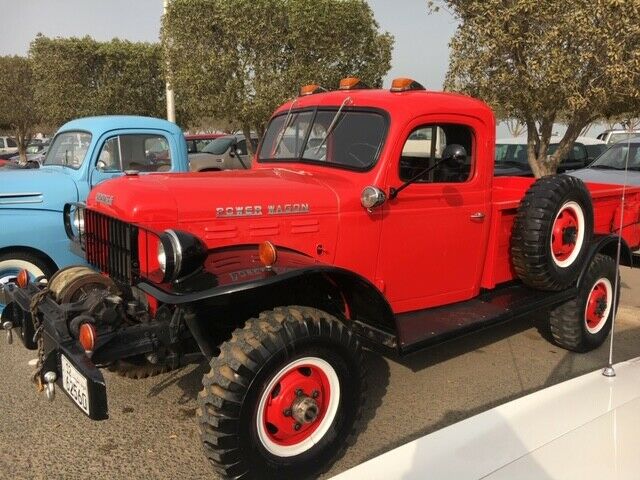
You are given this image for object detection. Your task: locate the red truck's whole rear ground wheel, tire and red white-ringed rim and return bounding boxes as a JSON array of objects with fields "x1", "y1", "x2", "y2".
[{"x1": 550, "y1": 255, "x2": 620, "y2": 352}]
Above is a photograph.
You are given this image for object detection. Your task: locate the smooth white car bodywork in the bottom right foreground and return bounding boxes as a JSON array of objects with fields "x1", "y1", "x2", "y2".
[{"x1": 333, "y1": 357, "x2": 640, "y2": 480}]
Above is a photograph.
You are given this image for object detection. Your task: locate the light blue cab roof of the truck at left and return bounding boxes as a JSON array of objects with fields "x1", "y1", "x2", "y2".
[{"x1": 58, "y1": 115, "x2": 182, "y2": 135}]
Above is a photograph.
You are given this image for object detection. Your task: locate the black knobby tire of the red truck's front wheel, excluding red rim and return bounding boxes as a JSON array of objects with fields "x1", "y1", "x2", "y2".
[{"x1": 197, "y1": 306, "x2": 365, "y2": 479}]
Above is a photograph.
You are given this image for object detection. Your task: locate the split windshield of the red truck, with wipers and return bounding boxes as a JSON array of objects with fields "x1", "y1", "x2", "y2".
[{"x1": 258, "y1": 109, "x2": 387, "y2": 170}]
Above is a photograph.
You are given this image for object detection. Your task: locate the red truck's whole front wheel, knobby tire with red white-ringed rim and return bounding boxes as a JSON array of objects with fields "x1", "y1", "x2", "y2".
[{"x1": 198, "y1": 306, "x2": 365, "y2": 479}]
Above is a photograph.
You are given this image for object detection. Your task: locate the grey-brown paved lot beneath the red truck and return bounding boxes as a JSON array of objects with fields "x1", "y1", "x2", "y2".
[{"x1": 0, "y1": 269, "x2": 640, "y2": 480}]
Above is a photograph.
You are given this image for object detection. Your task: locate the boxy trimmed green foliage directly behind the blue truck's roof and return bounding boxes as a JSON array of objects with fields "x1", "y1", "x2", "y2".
[{"x1": 29, "y1": 35, "x2": 165, "y2": 126}]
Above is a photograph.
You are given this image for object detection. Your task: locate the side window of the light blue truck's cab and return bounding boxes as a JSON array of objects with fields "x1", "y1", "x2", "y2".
[{"x1": 98, "y1": 134, "x2": 171, "y2": 172}]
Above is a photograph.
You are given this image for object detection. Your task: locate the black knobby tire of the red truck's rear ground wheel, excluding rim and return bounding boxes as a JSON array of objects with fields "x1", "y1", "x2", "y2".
[{"x1": 549, "y1": 254, "x2": 620, "y2": 352}]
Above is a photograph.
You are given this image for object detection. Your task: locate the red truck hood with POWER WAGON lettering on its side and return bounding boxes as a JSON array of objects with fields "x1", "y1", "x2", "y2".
[{"x1": 87, "y1": 169, "x2": 339, "y2": 254}]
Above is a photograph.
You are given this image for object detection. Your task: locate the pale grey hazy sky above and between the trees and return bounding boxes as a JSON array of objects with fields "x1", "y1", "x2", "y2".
[{"x1": 0, "y1": 0, "x2": 455, "y2": 89}]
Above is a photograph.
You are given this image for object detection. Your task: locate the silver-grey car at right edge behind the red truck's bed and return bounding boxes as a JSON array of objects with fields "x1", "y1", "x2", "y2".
[{"x1": 571, "y1": 136, "x2": 640, "y2": 185}]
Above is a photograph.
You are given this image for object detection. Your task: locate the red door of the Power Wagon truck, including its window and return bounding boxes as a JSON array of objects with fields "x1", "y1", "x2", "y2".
[{"x1": 376, "y1": 120, "x2": 493, "y2": 313}]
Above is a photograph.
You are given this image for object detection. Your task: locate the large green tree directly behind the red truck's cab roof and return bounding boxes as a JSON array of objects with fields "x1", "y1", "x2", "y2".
[{"x1": 162, "y1": 0, "x2": 393, "y2": 153}]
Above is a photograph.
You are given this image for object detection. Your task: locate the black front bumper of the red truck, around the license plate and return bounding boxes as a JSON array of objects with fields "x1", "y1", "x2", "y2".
[{"x1": 2, "y1": 284, "x2": 109, "y2": 420}]
